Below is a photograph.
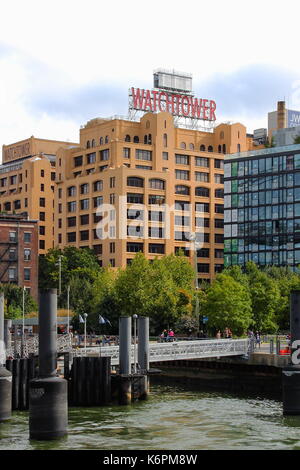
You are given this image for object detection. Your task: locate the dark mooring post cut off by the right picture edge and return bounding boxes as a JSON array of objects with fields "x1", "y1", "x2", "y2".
[{"x1": 282, "y1": 290, "x2": 300, "y2": 415}]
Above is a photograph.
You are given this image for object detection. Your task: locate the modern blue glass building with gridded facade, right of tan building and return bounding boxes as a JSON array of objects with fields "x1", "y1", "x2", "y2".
[{"x1": 224, "y1": 145, "x2": 300, "y2": 270}]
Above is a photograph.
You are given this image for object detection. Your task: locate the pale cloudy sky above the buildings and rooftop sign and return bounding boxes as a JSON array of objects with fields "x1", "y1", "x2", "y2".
[{"x1": 0, "y1": 0, "x2": 300, "y2": 151}]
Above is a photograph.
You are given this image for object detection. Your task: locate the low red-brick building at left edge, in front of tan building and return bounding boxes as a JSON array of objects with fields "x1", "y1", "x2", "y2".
[{"x1": 0, "y1": 214, "x2": 38, "y2": 300}]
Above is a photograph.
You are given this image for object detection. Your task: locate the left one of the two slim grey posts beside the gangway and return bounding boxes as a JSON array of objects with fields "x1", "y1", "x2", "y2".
[{"x1": 119, "y1": 317, "x2": 131, "y2": 405}]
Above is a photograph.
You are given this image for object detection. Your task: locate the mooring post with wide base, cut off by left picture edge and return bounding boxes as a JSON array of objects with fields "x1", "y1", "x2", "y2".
[{"x1": 0, "y1": 292, "x2": 12, "y2": 421}]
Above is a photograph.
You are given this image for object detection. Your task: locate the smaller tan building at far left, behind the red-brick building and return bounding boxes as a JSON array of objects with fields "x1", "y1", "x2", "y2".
[{"x1": 0, "y1": 136, "x2": 76, "y2": 254}]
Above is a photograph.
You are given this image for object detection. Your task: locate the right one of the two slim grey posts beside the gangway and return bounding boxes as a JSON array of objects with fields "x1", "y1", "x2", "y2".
[{"x1": 138, "y1": 317, "x2": 149, "y2": 399}]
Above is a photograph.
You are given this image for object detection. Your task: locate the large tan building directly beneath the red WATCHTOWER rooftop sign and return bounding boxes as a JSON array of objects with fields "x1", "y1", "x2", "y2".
[{"x1": 54, "y1": 112, "x2": 252, "y2": 280}]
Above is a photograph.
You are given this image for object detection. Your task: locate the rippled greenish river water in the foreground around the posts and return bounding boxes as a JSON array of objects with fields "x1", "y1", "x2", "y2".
[{"x1": 0, "y1": 384, "x2": 300, "y2": 450}]
